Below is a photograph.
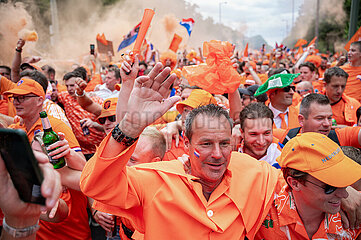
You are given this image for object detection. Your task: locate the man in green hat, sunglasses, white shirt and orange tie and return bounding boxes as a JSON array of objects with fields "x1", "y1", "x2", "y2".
[{"x1": 254, "y1": 73, "x2": 299, "y2": 129}]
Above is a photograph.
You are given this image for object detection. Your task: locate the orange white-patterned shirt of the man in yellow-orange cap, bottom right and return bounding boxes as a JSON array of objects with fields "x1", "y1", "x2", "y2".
[{"x1": 255, "y1": 184, "x2": 361, "y2": 240}]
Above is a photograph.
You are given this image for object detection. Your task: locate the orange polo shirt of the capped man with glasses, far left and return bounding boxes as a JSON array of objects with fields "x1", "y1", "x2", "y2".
[{"x1": 9, "y1": 116, "x2": 80, "y2": 151}]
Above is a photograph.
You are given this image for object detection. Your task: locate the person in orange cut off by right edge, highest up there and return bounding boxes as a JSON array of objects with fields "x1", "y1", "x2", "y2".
[{"x1": 341, "y1": 41, "x2": 361, "y2": 102}]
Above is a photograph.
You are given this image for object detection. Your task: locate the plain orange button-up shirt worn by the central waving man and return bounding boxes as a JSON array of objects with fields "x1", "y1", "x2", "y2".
[{"x1": 80, "y1": 135, "x2": 283, "y2": 240}]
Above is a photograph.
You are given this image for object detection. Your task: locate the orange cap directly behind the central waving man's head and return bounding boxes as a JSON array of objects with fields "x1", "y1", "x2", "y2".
[{"x1": 176, "y1": 89, "x2": 217, "y2": 113}]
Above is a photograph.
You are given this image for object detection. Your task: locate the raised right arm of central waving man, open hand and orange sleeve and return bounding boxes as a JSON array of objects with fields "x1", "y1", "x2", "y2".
[{"x1": 80, "y1": 63, "x2": 179, "y2": 204}]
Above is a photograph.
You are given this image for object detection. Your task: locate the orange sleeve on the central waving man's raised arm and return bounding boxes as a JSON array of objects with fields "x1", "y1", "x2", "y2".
[{"x1": 80, "y1": 134, "x2": 141, "y2": 209}]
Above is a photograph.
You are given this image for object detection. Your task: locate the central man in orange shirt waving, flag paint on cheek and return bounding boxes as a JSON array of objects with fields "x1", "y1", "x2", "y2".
[{"x1": 81, "y1": 63, "x2": 279, "y2": 239}]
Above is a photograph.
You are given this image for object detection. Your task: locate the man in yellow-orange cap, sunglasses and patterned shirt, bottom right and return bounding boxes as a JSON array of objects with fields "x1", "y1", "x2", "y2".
[{"x1": 255, "y1": 132, "x2": 361, "y2": 240}]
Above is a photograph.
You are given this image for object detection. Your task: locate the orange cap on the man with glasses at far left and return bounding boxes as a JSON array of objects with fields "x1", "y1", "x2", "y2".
[{"x1": 4, "y1": 78, "x2": 45, "y2": 99}]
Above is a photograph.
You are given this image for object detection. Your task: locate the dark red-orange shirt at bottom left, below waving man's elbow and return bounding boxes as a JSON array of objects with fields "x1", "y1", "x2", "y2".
[{"x1": 36, "y1": 188, "x2": 91, "y2": 240}]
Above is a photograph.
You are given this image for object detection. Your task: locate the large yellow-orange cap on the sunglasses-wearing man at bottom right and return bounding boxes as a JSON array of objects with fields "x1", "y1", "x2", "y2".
[{"x1": 277, "y1": 132, "x2": 361, "y2": 187}]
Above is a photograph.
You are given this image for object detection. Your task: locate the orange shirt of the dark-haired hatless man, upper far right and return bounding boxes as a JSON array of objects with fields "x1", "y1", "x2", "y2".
[{"x1": 331, "y1": 94, "x2": 361, "y2": 126}]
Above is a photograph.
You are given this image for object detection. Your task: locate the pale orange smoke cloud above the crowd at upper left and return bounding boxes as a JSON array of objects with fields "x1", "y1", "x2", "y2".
[{"x1": 0, "y1": 0, "x2": 244, "y2": 71}]
